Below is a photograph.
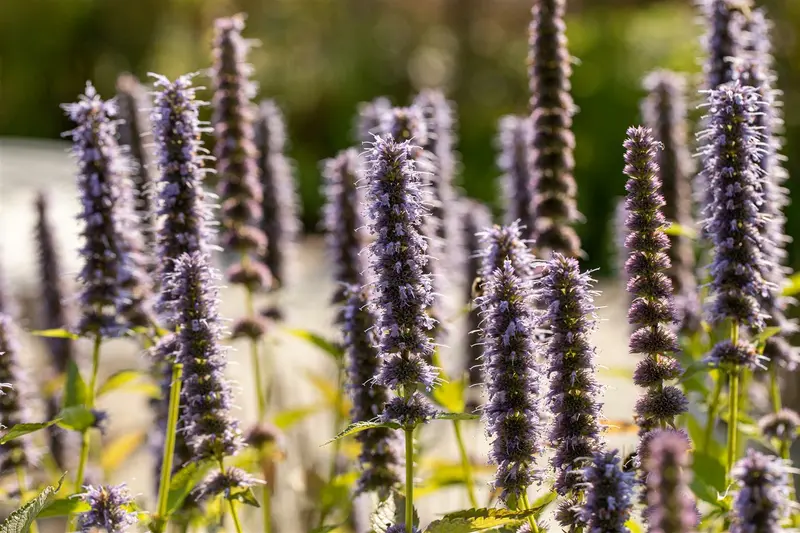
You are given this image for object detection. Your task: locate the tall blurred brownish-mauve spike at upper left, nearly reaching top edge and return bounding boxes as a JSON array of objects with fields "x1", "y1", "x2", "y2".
[{"x1": 211, "y1": 15, "x2": 266, "y2": 264}]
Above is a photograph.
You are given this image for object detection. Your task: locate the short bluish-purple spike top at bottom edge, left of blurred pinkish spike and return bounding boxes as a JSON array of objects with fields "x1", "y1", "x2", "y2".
[{"x1": 580, "y1": 450, "x2": 634, "y2": 533}]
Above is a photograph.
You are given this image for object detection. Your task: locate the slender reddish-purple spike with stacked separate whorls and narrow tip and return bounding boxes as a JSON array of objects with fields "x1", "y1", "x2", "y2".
[{"x1": 624, "y1": 127, "x2": 689, "y2": 433}]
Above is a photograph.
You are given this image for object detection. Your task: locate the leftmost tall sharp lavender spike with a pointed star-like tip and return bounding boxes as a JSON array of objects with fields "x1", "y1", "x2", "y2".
[{"x1": 62, "y1": 83, "x2": 145, "y2": 337}]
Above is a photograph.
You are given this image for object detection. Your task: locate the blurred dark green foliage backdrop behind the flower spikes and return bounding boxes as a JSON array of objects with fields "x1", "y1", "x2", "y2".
[{"x1": 0, "y1": 0, "x2": 800, "y2": 271}]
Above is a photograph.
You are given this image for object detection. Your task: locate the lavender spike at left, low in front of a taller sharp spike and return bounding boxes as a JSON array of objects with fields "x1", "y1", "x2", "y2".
[{"x1": 169, "y1": 252, "x2": 243, "y2": 461}]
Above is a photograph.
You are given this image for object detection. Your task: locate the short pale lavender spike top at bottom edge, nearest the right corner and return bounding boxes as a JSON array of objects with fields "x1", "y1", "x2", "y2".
[{"x1": 730, "y1": 449, "x2": 791, "y2": 533}]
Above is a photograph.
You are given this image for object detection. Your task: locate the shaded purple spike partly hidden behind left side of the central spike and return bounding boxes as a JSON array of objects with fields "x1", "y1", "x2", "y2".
[{"x1": 342, "y1": 284, "x2": 402, "y2": 497}]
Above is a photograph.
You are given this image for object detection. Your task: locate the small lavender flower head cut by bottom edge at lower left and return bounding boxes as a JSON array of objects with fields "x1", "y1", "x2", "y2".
[{"x1": 78, "y1": 484, "x2": 138, "y2": 533}]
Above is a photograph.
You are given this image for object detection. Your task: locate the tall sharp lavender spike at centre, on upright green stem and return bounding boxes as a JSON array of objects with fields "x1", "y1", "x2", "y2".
[{"x1": 367, "y1": 136, "x2": 437, "y2": 427}]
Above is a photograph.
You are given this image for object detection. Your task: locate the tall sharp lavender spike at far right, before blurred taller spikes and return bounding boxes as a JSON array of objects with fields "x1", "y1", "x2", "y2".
[{"x1": 702, "y1": 84, "x2": 770, "y2": 330}]
